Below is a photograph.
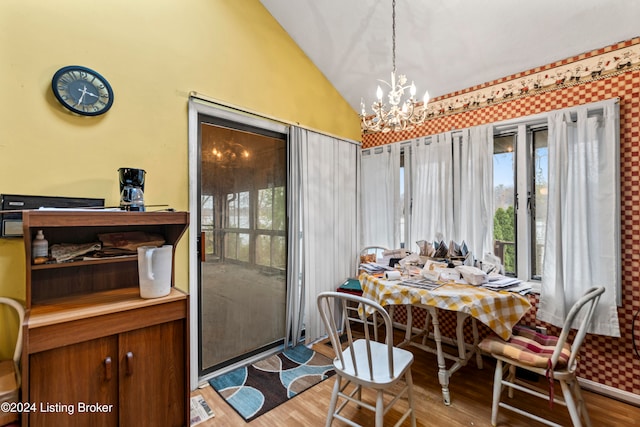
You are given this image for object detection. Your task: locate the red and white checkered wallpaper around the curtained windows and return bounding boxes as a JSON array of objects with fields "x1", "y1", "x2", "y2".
[{"x1": 362, "y1": 37, "x2": 640, "y2": 394}]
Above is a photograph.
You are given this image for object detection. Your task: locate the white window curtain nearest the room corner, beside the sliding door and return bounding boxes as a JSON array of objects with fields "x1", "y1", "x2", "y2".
[{"x1": 360, "y1": 143, "x2": 401, "y2": 249}]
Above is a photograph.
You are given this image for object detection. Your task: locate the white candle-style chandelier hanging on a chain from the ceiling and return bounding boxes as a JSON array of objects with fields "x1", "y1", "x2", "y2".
[{"x1": 360, "y1": 0, "x2": 429, "y2": 133}]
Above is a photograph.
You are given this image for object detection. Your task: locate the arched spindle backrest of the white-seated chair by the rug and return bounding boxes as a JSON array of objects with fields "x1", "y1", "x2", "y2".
[{"x1": 317, "y1": 292, "x2": 394, "y2": 380}]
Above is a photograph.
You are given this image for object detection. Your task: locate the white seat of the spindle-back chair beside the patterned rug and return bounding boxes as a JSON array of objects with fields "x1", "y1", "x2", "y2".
[{"x1": 334, "y1": 339, "x2": 413, "y2": 385}]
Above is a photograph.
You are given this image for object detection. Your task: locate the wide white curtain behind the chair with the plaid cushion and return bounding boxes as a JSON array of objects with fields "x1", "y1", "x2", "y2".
[{"x1": 537, "y1": 104, "x2": 620, "y2": 337}]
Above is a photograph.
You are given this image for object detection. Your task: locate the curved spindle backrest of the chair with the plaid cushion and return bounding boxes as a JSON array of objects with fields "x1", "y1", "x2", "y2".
[{"x1": 551, "y1": 286, "x2": 604, "y2": 370}]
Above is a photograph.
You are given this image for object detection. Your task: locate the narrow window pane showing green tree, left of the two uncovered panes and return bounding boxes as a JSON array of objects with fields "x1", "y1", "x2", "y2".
[{"x1": 493, "y1": 135, "x2": 516, "y2": 274}]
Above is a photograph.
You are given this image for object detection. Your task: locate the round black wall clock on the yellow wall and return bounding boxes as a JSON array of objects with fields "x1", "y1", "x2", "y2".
[{"x1": 51, "y1": 65, "x2": 113, "y2": 116}]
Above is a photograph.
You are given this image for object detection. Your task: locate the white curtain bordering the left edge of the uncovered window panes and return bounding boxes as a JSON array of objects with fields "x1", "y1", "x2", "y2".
[{"x1": 452, "y1": 125, "x2": 494, "y2": 260}]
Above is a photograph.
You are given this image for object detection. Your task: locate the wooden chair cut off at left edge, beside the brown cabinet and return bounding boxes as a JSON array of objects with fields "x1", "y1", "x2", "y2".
[{"x1": 0, "y1": 297, "x2": 24, "y2": 425}]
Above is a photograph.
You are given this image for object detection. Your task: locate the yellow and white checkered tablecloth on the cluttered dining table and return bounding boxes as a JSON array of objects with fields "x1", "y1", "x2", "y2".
[{"x1": 360, "y1": 273, "x2": 531, "y2": 340}]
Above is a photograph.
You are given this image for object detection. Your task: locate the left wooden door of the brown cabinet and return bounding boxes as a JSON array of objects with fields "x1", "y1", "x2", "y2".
[{"x1": 25, "y1": 336, "x2": 118, "y2": 427}]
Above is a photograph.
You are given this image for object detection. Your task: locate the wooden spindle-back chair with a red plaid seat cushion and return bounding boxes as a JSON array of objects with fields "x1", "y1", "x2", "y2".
[{"x1": 479, "y1": 287, "x2": 604, "y2": 426}]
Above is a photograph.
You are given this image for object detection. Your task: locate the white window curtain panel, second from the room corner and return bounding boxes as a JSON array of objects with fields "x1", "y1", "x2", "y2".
[{"x1": 407, "y1": 132, "x2": 454, "y2": 252}]
